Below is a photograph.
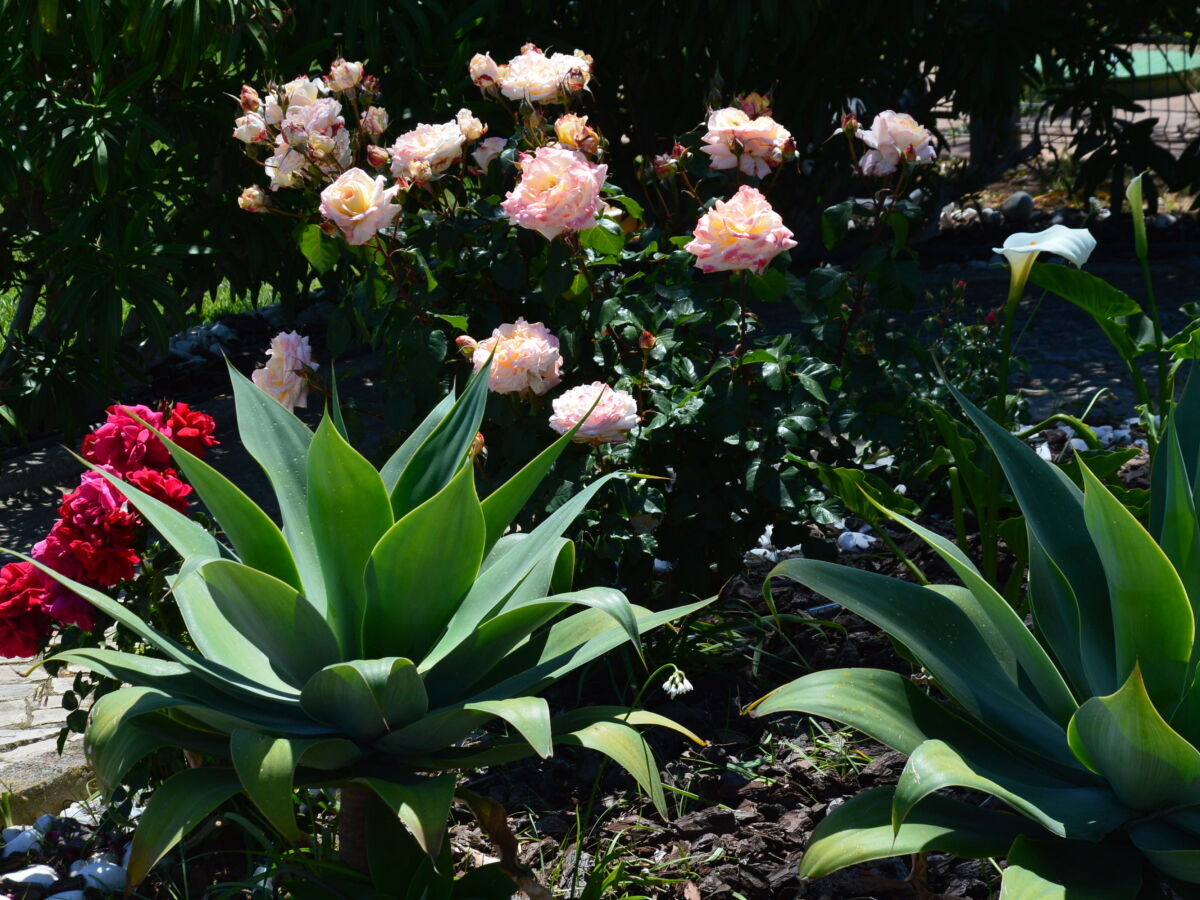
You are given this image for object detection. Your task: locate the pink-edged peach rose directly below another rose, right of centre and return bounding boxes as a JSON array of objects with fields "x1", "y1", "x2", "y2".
[{"x1": 684, "y1": 185, "x2": 796, "y2": 272}]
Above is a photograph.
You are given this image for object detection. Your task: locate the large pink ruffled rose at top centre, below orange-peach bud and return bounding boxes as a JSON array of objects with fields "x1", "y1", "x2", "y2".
[{"x1": 500, "y1": 146, "x2": 608, "y2": 240}]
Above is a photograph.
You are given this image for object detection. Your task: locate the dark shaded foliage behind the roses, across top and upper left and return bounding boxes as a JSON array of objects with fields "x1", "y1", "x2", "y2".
[{"x1": 0, "y1": 0, "x2": 1200, "y2": 442}]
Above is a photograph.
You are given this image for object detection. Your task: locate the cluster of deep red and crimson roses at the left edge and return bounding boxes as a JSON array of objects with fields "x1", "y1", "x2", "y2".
[{"x1": 0, "y1": 403, "x2": 217, "y2": 656}]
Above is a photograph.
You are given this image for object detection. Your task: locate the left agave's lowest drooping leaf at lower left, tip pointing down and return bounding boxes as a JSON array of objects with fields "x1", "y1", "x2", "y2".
[{"x1": 127, "y1": 767, "x2": 241, "y2": 888}]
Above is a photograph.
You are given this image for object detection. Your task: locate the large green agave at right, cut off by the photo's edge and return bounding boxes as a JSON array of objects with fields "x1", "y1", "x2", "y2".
[{"x1": 751, "y1": 379, "x2": 1200, "y2": 900}]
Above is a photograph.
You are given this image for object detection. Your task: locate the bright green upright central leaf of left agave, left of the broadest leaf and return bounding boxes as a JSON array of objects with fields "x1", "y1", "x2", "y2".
[{"x1": 307, "y1": 416, "x2": 392, "y2": 659}]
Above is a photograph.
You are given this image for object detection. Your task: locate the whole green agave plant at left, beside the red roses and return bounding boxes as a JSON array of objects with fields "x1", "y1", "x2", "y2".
[{"x1": 14, "y1": 366, "x2": 707, "y2": 893}]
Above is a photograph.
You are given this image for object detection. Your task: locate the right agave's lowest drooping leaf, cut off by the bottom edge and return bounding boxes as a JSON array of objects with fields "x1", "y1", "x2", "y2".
[{"x1": 1000, "y1": 835, "x2": 1142, "y2": 900}]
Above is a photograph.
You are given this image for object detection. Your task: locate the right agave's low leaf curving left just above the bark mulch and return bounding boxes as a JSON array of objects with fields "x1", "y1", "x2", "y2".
[{"x1": 799, "y1": 787, "x2": 1044, "y2": 878}]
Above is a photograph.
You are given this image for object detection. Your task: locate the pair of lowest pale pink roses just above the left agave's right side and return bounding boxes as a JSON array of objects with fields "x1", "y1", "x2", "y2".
[{"x1": 457, "y1": 318, "x2": 637, "y2": 445}]
